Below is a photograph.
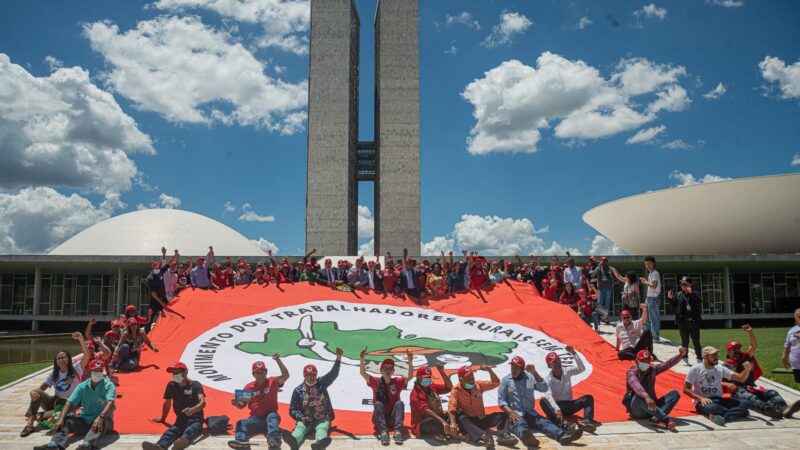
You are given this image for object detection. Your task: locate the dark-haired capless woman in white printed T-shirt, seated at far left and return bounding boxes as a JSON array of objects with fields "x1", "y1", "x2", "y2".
[{"x1": 19, "y1": 338, "x2": 89, "y2": 437}]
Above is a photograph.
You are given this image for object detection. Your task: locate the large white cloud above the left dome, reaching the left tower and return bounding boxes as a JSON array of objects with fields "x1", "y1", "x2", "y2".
[{"x1": 84, "y1": 17, "x2": 307, "y2": 134}]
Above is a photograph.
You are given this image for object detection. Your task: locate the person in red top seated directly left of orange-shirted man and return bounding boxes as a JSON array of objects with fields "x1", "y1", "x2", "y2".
[{"x1": 410, "y1": 362, "x2": 461, "y2": 443}]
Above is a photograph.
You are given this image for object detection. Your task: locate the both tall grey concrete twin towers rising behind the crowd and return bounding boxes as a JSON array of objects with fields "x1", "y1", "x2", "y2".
[{"x1": 306, "y1": 0, "x2": 420, "y2": 255}]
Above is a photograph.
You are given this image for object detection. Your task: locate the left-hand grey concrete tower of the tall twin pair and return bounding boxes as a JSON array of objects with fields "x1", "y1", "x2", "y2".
[{"x1": 306, "y1": 0, "x2": 360, "y2": 255}]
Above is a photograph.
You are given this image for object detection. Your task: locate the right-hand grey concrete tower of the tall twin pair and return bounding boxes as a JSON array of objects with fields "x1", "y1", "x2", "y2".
[{"x1": 375, "y1": 0, "x2": 420, "y2": 255}]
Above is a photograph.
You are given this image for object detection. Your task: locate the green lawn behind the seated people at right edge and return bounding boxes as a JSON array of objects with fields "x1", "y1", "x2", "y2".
[{"x1": 661, "y1": 328, "x2": 800, "y2": 389}]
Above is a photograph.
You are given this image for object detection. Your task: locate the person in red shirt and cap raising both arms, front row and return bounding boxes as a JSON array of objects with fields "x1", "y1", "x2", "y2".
[{"x1": 359, "y1": 347, "x2": 414, "y2": 445}]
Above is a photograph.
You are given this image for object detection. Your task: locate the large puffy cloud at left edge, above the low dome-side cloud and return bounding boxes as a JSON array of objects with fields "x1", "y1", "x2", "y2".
[{"x1": 0, "y1": 53, "x2": 155, "y2": 194}]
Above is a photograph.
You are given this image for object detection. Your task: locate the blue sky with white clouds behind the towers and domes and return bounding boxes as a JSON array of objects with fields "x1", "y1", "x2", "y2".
[{"x1": 0, "y1": 0, "x2": 800, "y2": 254}]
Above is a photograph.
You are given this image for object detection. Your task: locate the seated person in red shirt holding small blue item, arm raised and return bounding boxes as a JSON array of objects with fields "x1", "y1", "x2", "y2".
[{"x1": 228, "y1": 353, "x2": 289, "y2": 449}]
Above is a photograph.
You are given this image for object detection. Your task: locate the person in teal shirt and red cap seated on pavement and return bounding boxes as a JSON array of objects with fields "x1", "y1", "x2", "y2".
[{"x1": 34, "y1": 359, "x2": 117, "y2": 450}]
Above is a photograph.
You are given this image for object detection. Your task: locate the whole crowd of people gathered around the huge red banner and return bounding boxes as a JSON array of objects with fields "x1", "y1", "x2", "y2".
[{"x1": 20, "y1": 247, "x2": 800, "y2": 450}]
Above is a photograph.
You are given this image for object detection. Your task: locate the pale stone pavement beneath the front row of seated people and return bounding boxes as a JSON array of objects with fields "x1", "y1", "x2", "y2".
[{"x1": 0, "y1": 326, "x2": 800, "y2": 450}]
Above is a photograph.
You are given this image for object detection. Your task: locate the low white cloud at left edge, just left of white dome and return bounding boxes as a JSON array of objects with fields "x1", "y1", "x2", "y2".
[{"x1": 0, "y1": 187, "x2": 125, "y2": 254}]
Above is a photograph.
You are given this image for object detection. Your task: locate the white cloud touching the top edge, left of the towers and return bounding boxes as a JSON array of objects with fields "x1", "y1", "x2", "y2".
[{"x1": 153, "y1": 0, "x2": 311, "y2": 55}]
